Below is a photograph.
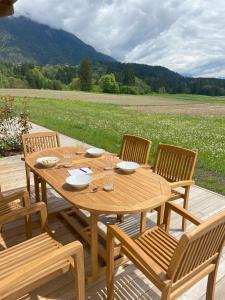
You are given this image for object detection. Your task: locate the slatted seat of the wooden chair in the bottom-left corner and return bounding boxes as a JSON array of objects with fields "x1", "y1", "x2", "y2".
[{"x1": 0, "y1": 233, "x2": 70, "y2": 288}]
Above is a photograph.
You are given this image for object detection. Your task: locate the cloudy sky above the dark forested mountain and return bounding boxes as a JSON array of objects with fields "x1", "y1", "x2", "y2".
[{"x1": 15, "y1": 0, "x2": 225, "y2": 78}]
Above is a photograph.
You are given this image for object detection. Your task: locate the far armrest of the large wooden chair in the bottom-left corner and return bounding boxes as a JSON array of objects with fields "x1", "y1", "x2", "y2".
[{"x1": 0, "y1": 202, "x2": 47, "y2": 229}]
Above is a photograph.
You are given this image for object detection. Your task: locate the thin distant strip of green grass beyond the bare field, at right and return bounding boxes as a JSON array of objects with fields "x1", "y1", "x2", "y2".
[{"x1": 150, "y1": 93, "x2": 225, "y2": 104}]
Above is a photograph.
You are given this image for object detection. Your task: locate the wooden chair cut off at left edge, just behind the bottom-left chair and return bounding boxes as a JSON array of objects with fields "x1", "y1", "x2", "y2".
[{"x1": 0, "y1": 186, "x2": 31, "y2": 238}]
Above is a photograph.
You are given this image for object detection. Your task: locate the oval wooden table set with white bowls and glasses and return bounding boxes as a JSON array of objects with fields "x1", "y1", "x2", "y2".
[{"x1": 25, "y1": 145, "x2": 171, "y2": 281}]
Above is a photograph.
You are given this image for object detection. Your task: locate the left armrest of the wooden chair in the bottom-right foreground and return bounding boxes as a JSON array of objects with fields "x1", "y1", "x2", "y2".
[{"x1": 107, "y1": 225, "x2": 169, "y2": 281}]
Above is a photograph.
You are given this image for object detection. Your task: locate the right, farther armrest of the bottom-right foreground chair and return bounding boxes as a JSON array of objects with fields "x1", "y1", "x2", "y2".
[{"x1": 164, "y1": 202, "x2": 203, "y2": 225}]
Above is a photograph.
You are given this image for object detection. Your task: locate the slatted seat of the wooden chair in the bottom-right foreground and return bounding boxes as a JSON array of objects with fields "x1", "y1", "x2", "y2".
[{"x1": 135, "y1": 227, "x2": 178, "y2": 271}]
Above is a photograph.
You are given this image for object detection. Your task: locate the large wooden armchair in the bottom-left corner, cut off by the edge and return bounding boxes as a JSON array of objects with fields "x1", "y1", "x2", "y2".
[{"x1": 0, "y1": 202, "x2": 85, "y2": 300}]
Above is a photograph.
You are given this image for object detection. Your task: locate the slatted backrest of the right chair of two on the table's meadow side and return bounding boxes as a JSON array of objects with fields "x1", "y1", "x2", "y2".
[{"x1": 153, "y1": 144, "x2": 197, "y2": 182}]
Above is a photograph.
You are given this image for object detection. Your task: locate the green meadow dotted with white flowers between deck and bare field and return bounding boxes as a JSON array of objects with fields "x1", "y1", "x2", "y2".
[{"x1": 18, "y1": 98, "x2": 225, "y2": 194}]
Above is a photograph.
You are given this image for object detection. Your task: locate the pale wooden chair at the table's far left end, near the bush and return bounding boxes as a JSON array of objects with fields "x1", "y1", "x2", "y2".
[{"x1": 22, "y1": 131, "x2": 60, "y2": 201}]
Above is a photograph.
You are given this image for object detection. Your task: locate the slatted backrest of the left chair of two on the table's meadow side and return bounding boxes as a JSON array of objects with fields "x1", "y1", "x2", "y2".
[{"x1": 120, "y1": 134, "x2": 151, "y2": 164}]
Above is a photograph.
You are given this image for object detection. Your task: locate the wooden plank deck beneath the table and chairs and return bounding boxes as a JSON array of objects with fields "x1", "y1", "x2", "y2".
[{"x1": 0, "y1": 126, "x2": 225, "y2": 300}]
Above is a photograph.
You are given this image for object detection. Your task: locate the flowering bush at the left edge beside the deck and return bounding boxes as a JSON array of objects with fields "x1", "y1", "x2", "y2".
[{"x1": 0, "y1": 97, "x2": 30, "y2": 156}]
